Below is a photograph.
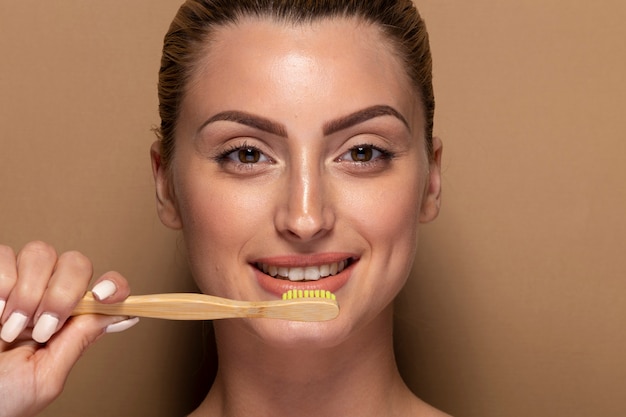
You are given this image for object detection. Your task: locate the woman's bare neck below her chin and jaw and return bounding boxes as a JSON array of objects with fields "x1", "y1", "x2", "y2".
[{"x1": 188, "y1": 307, "x2": 436, "y2": 417}]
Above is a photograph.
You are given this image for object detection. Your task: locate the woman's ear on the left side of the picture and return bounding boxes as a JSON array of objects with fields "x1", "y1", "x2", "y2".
[{"x1": 150, "y1": 141, "x2": 182, "y2": 230}]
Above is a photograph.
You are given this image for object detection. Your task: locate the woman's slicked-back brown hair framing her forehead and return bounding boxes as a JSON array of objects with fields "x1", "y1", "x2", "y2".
[{"x1": 156, "y1": 0, "x2": 435, "y2": 167}]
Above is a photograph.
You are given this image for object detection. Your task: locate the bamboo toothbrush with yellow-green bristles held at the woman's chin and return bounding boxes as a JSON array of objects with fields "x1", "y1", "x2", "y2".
[{"x1": 72, "y1": 290, "x2": 339, "y2": 321}]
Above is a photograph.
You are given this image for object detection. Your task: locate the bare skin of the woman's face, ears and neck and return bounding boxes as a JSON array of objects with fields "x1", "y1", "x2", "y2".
[{"x1": 152, "y1": 20, "x2": 443, "y2": 416}]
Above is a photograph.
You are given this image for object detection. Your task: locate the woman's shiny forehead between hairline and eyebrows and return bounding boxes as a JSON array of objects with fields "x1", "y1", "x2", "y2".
[{"x1": 180, "y1": 18, "x2": 416, "y2": 128}]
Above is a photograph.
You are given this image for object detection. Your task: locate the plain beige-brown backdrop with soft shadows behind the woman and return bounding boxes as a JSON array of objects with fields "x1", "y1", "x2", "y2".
[{"x1": 0, "y1": 0, "x2": 626, "y2": 417}]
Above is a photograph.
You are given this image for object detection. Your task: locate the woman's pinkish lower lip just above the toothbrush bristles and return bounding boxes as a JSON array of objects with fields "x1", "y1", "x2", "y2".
[{"x1": 252, "y1": 262, "x2": 356, "y2": 297}]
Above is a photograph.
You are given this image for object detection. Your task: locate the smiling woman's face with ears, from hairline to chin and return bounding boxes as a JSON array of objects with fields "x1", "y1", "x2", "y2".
[{"x1": 153, "y1": 19, "x2": 440, "y2": 343}]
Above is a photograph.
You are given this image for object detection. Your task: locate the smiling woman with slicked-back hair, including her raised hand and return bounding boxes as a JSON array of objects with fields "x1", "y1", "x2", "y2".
[{"x1": 0, "y1": 0, "x2": 445, "y2": 416}]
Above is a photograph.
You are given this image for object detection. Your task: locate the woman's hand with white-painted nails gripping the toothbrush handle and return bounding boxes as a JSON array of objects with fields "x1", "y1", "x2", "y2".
[{"x1": 0, "y1": 242, "x2": 136, "y2": 417}]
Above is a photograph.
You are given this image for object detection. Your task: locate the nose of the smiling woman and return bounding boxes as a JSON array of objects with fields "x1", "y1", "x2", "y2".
[{"x1": 275, "y1": 162, "x2": 335, "y2": 242}]
